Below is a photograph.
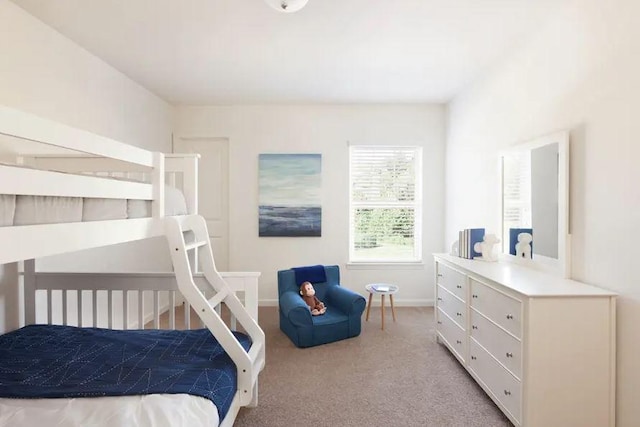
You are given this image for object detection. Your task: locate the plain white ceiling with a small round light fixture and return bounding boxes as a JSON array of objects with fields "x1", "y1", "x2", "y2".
[{"x1": 13, "y1": 0, "x2": 563, "y2": 105}]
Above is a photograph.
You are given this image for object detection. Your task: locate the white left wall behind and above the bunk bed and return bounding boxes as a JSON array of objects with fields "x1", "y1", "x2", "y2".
[{"x1": 0, "y1": 0, "x2": 172, "y2": 330}]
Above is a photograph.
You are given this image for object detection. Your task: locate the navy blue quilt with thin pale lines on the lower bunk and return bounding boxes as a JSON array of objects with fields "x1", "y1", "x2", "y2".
[{"x1": 0, "y1": 325, "x2": 251, "y2": 420}]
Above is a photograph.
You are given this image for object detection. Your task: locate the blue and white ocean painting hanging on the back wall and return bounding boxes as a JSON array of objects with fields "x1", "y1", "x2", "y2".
[{"x1": 258, "y1": 154, "x2": 322, "y2": 237}]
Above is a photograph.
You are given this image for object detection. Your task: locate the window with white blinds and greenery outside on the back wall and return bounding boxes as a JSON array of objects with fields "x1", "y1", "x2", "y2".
[{"x1": 349, "y1": 145, "x2": 422, "y2": 263}]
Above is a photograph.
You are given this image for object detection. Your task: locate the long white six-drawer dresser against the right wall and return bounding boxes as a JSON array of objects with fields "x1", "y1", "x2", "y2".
[{"x1": 434, "y1": 254, "x2": 616, "y2": 427}]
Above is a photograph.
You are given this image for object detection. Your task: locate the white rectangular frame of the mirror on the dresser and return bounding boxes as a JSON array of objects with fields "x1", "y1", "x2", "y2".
[{"x1": 500, "y1": 131, "x2": 571, "y2": 278}]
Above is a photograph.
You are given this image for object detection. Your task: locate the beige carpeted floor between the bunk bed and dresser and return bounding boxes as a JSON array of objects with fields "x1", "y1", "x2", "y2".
[{"x1": 234, "y1": 307, "x2": 511, "y2": 427}]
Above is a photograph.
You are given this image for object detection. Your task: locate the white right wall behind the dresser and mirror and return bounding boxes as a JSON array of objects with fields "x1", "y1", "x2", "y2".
[{"x1": 445, "y1": 0, "x2": 640, "y2": 427}]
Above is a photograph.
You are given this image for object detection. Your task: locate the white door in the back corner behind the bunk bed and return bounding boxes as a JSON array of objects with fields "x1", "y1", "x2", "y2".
[{"x1": 173, "y1": 136, "x2": 229, "y2": 271}]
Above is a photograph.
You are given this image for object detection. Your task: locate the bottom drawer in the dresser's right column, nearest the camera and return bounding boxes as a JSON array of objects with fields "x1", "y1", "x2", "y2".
[{"x1": 469, "y1": 338, "x2": 522, "y2": 423}]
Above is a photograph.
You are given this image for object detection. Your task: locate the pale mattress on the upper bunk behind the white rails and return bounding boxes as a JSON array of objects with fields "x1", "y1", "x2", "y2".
[{"x1": 0, "y1": 186, "x2": 188, "y2": 227}]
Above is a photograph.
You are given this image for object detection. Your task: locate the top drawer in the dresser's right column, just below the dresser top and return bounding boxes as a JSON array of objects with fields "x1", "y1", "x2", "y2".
[{"x1": 470, "y1": 279, "x2": 522, "y2": 338}]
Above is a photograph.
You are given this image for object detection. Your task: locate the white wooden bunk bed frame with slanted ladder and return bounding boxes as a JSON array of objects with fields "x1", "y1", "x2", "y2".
[{"x1": 0, "y1": 106, "x2": 265, "y2": 427}]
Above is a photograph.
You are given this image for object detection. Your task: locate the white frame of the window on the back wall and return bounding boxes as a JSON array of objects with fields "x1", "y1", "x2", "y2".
[{"x1": 348, "y1": 144, "x2": 424, "y2": 268}]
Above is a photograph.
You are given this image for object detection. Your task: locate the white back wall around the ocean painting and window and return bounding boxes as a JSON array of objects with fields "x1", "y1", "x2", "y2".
[{"x1": 175, "y1": 105, "x2": 445, "y2": 304}]
